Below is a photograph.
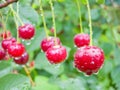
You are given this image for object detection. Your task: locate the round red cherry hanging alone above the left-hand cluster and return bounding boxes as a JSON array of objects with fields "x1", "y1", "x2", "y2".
[{"x1": 18, "y1": 24, "x2": 35, "y2": 40}]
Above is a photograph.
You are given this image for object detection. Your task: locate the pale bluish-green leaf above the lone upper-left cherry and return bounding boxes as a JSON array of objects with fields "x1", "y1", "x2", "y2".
[{"x1": 19, "y1": 5, "x2": 39, "y2": 24}]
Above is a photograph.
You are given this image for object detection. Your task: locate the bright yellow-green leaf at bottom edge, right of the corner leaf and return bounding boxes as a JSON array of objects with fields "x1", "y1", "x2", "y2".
[{"x1": 33, "y1": 76, "x2": 60, "y2": 90}]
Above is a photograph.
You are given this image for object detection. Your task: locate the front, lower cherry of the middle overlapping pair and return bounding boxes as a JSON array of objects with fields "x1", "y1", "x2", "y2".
[{"x1": 46, "y1": 45, "x2": 67, "y2": 64}]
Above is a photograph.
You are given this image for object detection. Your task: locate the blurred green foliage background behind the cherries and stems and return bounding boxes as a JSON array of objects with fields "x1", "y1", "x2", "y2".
[{"x1": 0, "y1": 0, "x2": 120, "y2": 90}]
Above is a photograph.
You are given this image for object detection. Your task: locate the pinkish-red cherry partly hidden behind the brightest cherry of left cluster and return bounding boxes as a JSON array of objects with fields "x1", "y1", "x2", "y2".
[{"x1": 2, "y1": 38, "x2": 16, "y2": 50}]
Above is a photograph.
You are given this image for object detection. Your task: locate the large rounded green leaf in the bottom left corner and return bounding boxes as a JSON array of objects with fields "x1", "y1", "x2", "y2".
[{"x1": 0, "y1": 74, "x2": 30, "y2": 90}]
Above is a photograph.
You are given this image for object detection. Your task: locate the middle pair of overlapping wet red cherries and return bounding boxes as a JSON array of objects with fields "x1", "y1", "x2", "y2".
[{"x1": 40, "y1": 36, "x2": 67, "y2": 64}]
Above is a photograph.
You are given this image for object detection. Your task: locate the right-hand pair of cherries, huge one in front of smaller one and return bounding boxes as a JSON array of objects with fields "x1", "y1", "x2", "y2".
[{"x1": 74, "y1": 33, "x2": 104, "y2": 75}]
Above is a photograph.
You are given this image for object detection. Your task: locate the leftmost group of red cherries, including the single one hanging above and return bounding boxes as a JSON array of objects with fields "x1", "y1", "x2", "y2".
[{"x1": 0, "y1": 24, "x2": 35, "y2": 65}]
